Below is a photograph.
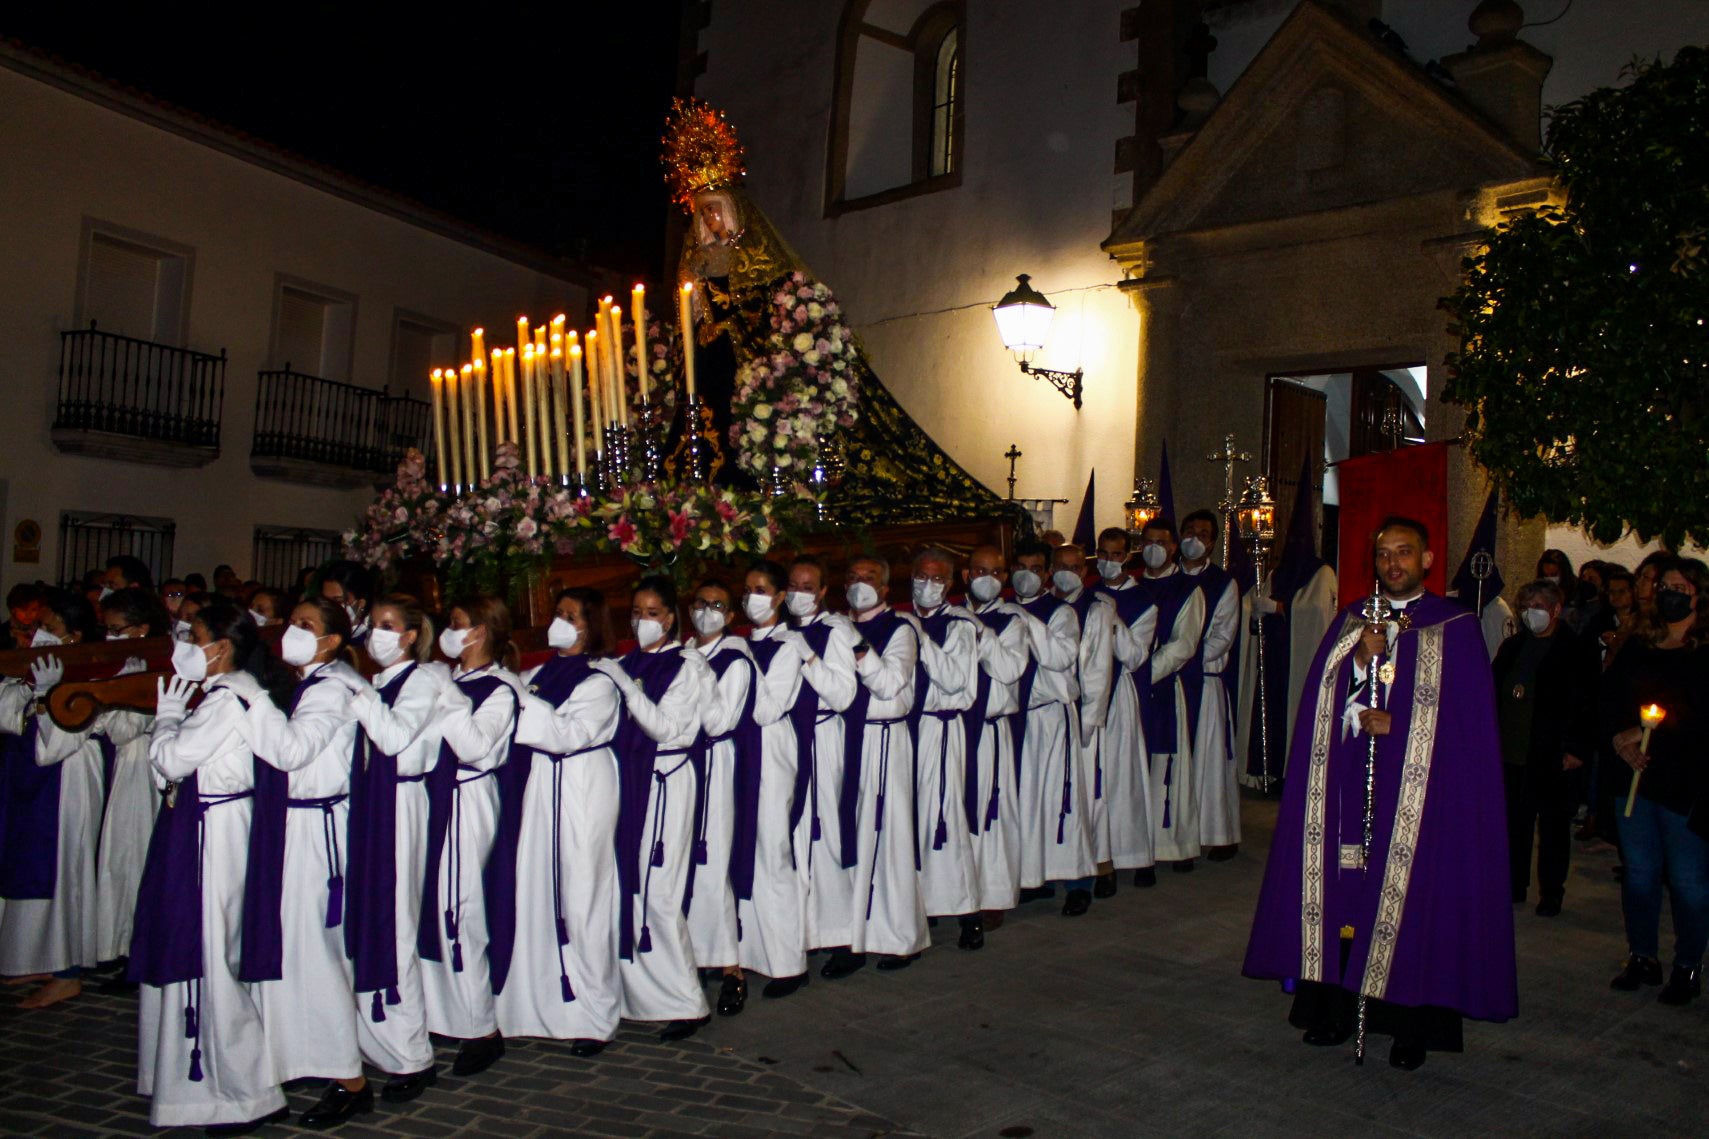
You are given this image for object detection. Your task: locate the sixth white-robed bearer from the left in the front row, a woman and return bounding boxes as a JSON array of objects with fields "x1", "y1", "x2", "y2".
[{"x1": 593, "y1": 576, "x2": 713, "y2": 1040}]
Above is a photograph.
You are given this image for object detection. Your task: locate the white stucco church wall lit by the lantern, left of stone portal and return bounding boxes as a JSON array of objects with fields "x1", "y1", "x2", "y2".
[{"x1": 696, "y1": 0, "x2": 1138, "y2": 525}]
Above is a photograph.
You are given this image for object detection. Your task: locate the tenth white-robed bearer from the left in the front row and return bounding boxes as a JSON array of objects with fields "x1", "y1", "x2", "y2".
[{"x1": 820, "y1": 558, "x2": 926, "y2": 980}]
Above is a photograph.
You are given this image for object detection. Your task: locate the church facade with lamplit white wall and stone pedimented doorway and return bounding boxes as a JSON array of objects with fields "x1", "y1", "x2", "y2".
[{"x1": 684, "y1": 0, "x2": 1709, "y2": 581}]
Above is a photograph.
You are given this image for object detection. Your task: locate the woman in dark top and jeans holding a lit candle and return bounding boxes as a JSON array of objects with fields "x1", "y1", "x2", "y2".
[{"x1": 1603, "y1": 558, "x2": 1709, "y2": 1006}]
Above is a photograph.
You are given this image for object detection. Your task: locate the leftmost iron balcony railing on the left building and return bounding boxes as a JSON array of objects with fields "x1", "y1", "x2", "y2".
[{"x1": 53, "y1": 320, "x2": 226, "y2": 450}]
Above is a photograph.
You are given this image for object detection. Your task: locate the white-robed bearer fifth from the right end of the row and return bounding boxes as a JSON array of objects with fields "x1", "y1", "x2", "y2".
[{"x1": 1003, "y1": 542, "x2": 1092, "y2": 917}]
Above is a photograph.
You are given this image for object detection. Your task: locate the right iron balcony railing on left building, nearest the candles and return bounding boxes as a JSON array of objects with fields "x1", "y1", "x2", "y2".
[{"x1": 250, "y1": 361, "x2": 431, "y2": 474}]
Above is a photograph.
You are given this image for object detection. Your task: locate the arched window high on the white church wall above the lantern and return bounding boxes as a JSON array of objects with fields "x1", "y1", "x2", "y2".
[{"x1": 825, "y1": 0, "x2": 966, "y2": 215}]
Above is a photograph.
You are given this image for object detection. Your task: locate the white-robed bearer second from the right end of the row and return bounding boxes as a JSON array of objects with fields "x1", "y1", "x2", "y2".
[{"x1": 1140, "y1": 518, "x2": 1205, "y2": 870}]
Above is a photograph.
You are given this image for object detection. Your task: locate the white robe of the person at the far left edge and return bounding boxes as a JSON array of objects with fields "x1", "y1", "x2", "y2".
[{"x1": 0, "y1": 681, "x2": 101, "y2": 977}]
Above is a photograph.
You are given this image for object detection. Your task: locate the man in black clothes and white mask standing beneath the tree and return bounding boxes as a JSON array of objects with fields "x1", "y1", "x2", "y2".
[{"x1": 1492, "y1": 580, "x2": 1600, "y2": 917}]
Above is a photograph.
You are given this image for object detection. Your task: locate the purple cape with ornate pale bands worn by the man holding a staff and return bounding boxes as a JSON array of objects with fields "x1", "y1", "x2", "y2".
[{"x1": 1242, "y1": 593, "x2": 1518, "y2": 1021}]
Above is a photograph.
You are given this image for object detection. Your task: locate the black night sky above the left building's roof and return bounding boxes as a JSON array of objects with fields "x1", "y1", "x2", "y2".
[{"x1": 0, "y1": 0, "x2": 680, "y2": 279}]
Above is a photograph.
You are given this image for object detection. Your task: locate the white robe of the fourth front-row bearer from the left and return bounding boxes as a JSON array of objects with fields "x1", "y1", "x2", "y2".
[{"x1": 420, "y1": 664, "x2": 520, "y2": 1040}]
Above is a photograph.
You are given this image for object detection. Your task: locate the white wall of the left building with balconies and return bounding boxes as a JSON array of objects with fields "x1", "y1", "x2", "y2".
[{"x1": 0, "y1": 67, "x2": 586, "y2": 585}]
